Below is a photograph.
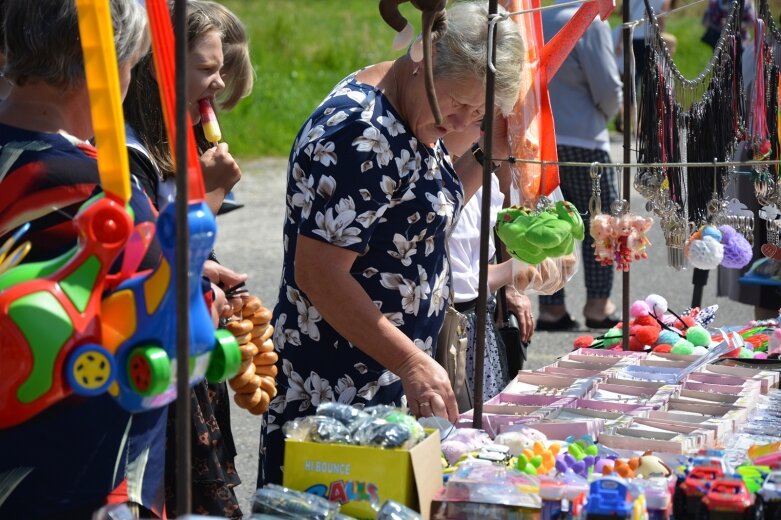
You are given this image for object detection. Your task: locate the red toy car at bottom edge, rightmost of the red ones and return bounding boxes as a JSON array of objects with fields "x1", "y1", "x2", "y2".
[{"x1": 698, "y1": 479, "x2": 764, "y2": 520}]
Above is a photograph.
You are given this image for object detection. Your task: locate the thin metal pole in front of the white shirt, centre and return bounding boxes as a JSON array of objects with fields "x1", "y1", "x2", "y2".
[{"x1": 472, "y1": 0, "x2": 497, "y2": 429}]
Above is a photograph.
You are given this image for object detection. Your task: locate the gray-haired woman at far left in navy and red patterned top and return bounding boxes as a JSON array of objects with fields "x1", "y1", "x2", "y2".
[{"x1": 0, "y1": 0, "x2": 166, "y2": 520}]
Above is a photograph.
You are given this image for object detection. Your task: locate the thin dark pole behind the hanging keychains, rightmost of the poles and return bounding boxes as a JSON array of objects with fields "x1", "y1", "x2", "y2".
[{"x1": 620, "y1": 0, "x2": 635, "y2": 350}]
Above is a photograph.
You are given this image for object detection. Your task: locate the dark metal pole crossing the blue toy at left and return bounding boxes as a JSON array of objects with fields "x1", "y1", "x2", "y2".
[{"x1": 174, "y1": 0, "x2": 192, "y2": 516}]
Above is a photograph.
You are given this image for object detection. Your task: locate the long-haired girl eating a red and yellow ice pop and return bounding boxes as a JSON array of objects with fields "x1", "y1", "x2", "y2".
[{"x1": 124, "y1": 0, "x2": 254, "y2": 518}]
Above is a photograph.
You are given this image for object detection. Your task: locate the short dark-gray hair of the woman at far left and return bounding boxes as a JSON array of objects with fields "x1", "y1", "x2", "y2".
[{"x1": 4, "y1": 0, "x2": 149, "y2": 90}]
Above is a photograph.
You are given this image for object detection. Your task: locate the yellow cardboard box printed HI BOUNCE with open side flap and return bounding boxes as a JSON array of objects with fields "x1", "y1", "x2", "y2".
[{"x1": 283, "y1": 432, "x2": 442, "y2": 518}]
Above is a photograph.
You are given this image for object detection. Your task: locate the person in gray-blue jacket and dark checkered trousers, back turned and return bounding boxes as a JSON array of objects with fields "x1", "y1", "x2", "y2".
[{"x1": 537, "y1": 0, "x2": 622, "y2": 331}]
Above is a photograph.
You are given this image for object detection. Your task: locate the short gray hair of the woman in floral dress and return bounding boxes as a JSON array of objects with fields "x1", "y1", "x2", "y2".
[{"x1": 434, "y1": 0, "x2": 524, "y2": 115}]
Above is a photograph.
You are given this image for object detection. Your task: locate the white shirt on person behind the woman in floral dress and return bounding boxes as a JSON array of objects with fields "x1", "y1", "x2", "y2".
[{"x1": 448, "y1": 174, "x2": 504, "y2": 303}]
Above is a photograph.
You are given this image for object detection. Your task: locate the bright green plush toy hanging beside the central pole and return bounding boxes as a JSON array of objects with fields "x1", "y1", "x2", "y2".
[{"x1": 496, "y1": 201, "x2": 585, "y2": 265}]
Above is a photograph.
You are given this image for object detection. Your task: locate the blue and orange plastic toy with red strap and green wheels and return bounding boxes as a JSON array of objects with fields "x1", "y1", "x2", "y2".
[{"x1": 102, "y1": 0, "x2": 241, "y2": 412}]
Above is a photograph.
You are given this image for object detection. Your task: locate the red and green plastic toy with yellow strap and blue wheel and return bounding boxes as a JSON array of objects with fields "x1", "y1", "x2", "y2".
[{"x1": 0, "y1": 0, "x2": 133, "y2": 428}]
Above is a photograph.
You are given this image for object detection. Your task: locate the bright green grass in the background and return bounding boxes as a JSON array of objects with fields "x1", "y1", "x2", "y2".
[{"x1": 220, "y1": 0, "x2": 781, "y2": 158}]
